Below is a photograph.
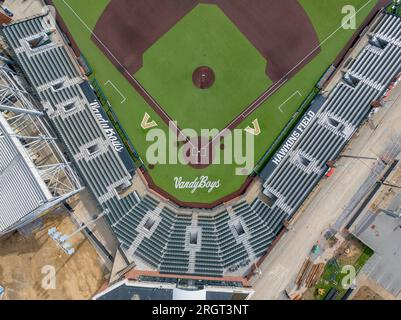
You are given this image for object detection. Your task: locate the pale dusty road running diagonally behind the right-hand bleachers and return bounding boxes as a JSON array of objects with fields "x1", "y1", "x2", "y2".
[{"x1": 252, "y1": 78, "x2": 401, "y2": 300}]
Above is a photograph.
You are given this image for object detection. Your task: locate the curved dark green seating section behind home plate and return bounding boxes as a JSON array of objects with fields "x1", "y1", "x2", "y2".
[{"x1": 113, "y1": 200, "x2": 284, "y2": 277}]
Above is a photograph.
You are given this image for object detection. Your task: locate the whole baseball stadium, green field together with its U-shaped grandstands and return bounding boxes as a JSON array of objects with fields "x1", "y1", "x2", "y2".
[{"x1": 2, "y1": 0, "x2": 401, "y2": 286}]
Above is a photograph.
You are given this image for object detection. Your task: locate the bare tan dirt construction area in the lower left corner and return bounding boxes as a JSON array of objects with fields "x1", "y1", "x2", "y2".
[{"x1": 0, "y1": 208, "x2": 106, "y2": 300}]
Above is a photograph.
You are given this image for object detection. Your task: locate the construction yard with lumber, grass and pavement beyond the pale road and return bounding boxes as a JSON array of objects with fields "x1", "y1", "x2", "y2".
[{"x1": 288, "y1": 151, "x2": 401, "y2": 300}]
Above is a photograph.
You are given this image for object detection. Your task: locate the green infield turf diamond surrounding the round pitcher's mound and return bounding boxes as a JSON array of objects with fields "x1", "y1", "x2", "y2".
[{"x1": 135, "y1": 5, "x2": 272, "y2": 131}]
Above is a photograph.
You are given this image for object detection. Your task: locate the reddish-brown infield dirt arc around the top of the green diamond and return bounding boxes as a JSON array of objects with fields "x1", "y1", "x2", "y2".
[{"x1": 92, "y1": 0, "x2": 320, "y2": 81}]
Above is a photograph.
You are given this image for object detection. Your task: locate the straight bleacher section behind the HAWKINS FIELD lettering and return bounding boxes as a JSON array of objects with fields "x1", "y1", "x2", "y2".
[{"x1": 264, "y1": 15, "x2": 401, "y2": 225}]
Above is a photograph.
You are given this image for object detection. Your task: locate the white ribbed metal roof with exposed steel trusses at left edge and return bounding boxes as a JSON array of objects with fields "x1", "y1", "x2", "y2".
[{"x1": 0, "y1": 65, "x2": 80, "y2": 235}]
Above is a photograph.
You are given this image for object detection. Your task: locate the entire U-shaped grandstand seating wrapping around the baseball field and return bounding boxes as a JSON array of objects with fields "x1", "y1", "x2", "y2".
[{"x1": 2, "y1": 8, "x2": 401, "y2": 286}]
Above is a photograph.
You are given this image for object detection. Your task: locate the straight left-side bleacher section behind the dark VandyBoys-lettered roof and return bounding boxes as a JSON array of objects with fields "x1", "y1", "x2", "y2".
[{"x1": 2, "y1": 16, "x2": 140, "y2": 248}]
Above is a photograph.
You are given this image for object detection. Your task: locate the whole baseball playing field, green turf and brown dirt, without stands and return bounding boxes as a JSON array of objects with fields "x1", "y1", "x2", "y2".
[{"x1": 53, "y1": 0, "x2": 385, "y2": 208}]
